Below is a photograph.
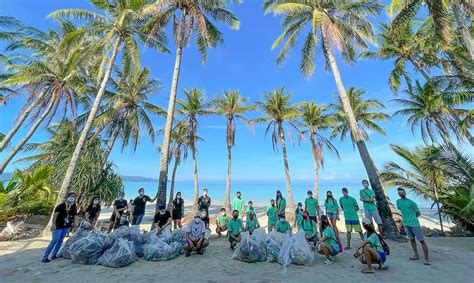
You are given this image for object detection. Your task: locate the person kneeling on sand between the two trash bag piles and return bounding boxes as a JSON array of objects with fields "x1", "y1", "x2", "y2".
[{"x1": 184, "y1": 212, "x2": 209, "y2": 257}]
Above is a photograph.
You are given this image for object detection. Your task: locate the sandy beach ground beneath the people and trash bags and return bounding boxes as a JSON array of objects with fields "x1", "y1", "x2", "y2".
[{"x1": 0, "y1": 203, "x2": 474, "y2": 282}]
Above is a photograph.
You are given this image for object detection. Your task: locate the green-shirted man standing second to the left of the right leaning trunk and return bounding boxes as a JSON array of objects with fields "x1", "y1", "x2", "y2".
[{"x1": 339, "y1": 188, "x2": 364, "y2": 250}]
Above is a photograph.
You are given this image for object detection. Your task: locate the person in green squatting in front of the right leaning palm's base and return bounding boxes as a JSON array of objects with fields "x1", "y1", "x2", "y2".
[{"x1": 354, "y1": 218, "x2": 387, "y2": 273}]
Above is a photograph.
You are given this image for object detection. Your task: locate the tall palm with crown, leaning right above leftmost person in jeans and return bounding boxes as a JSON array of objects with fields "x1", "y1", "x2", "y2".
[{"x1": 49, "y1": 0, "x2": 167, "y2": 205}]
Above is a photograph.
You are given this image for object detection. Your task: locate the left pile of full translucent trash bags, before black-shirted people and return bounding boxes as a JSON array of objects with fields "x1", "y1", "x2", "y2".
[{"x1": 58, "y1": 226, "x2": 186, "y2": 268}]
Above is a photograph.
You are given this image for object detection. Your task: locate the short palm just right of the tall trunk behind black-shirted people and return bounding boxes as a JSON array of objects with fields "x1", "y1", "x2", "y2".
[{"x1": 175, "y1": 88, "x2": 213, "y2": 215}]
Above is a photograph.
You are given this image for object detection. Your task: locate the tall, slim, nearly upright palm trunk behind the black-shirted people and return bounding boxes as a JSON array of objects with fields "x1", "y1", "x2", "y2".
[{"x1": 155, "y1": 10, "x2": 186, "y2": 211}]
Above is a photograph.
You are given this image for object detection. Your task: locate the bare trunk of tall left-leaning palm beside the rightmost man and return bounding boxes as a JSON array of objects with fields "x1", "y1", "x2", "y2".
[{"x1": 322, "y1": 29, "x2": 400, "y2": 239}]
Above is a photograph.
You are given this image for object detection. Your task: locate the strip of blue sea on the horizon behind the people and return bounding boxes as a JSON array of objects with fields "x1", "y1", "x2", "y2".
[{"x1": 125, "y1": 181, "x2": 431, "y2": 208}]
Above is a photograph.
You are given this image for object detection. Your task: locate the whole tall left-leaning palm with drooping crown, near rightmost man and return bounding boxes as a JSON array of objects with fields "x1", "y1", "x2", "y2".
[{"x1": 264, "y1": 0, "x2": 397, "y2": 237}]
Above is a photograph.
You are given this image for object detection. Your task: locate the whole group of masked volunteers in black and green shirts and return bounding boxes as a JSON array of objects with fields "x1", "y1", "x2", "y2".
[{"x1": 42, "y1": 180, "x2": 430, "y2": 273}]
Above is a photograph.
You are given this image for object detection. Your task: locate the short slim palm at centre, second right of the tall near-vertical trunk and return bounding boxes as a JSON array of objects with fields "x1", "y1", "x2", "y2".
[{"x1": 212, "y1": 90, "x2": 255, "y2": 210}]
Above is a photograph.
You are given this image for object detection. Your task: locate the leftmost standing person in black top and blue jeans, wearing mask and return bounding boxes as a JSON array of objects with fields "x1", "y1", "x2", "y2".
[{"x1": 41, "y1": 193, "x2": 77, "y2": 263}]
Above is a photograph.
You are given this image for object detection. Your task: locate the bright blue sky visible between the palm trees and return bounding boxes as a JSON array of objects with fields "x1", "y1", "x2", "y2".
[{"x1": 0, "y1": 0, "x2": 472, "y2": 181}]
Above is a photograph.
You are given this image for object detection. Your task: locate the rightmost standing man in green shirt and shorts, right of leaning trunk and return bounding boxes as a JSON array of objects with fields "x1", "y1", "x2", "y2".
[{"x1": 397, "y1": 187, "x2": 431, "y2": 265}]
